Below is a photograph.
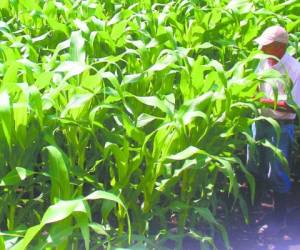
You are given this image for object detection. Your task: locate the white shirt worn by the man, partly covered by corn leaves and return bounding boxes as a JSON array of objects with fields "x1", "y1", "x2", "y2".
[{"x1": 257, "y1": 53, "x2": 300, "y2": 120}]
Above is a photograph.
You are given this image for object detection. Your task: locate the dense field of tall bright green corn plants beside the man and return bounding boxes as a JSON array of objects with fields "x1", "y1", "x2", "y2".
[{"x1": 0, "y1": 0, "x2": 300, "y2": 250}]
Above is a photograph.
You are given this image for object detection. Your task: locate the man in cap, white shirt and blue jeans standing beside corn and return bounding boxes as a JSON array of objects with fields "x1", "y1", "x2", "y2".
[{"x1": 247, "y1": 26, "x2": 300, "y2": 233}]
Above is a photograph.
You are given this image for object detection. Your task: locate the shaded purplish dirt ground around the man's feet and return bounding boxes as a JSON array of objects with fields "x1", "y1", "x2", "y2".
[{"x1": 226, "y1": 178, "x2": 300, "y2": 250}]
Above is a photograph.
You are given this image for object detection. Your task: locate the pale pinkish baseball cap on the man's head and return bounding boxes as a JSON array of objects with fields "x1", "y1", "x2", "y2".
[{"x1": 254, "y1": 25, "x2": 289, "y2": 46}]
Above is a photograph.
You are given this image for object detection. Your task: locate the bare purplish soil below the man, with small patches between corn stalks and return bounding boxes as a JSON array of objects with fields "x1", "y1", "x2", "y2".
[{"x1": 177, "y1": 175, "x2": 300, "y2": 250}]
